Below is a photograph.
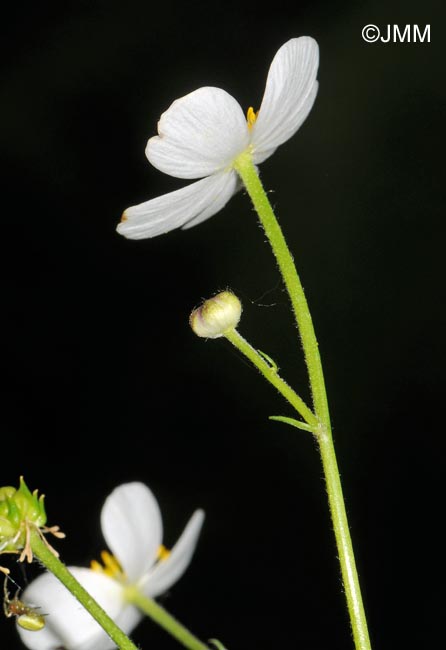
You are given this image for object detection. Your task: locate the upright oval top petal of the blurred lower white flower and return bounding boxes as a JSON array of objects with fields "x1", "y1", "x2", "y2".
[{"x1": 101, "y1": 482, "x2": 163, "y2": 582}]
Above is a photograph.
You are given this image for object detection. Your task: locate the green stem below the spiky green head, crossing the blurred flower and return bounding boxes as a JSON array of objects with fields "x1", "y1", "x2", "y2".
[{"x1": 30, "y1": 530, "x2": 138, "y2": 650}]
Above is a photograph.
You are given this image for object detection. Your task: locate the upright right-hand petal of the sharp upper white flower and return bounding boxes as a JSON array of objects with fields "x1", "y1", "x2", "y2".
[{"x1": 251, "y1": 36, "x2": 319, "y2": 164}]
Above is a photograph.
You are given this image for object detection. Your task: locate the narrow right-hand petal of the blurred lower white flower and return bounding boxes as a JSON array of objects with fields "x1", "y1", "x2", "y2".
[{"x1": 140, "y1": 510, "x2": 204, "y2": 598}]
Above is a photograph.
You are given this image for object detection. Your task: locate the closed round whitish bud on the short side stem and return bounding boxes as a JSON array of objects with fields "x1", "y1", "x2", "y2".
[{"x1": 189, "y1": 291, "x2": 242, "y2": 339}]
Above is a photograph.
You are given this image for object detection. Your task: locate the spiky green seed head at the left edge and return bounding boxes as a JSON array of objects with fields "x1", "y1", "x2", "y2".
[{"x1": 0, "y1": 476, "x2": 46, "y2": 553}]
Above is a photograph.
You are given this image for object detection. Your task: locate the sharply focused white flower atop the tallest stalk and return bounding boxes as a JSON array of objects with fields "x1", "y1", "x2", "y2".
[{"x1": 117, "y1": 36, "x2": 319, "y2": 239}]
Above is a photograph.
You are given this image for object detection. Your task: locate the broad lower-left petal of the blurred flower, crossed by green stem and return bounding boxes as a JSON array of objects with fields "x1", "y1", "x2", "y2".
[{"x1": 17, "y1": 567, "x2": 136, "y2": 650}]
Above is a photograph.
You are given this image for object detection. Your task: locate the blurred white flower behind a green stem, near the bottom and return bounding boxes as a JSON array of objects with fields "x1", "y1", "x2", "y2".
[{"x1": 17, "y1": 482, "x2": 204, "y2": 650}]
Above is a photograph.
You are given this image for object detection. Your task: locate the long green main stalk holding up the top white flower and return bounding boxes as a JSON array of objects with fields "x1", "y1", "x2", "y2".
[{"x1": 234, "y1": 151, "x2": 371, "y2": 650}]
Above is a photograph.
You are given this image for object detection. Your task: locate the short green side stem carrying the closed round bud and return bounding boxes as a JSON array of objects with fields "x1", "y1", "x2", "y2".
[{"x1": 224, "y1": 329, "x2": 318, "y2": 428}]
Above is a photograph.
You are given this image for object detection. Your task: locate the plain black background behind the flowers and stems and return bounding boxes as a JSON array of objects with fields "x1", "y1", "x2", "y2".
[{"x1": 0, "y1": 0, "x2": 445, "y2": 650}]
